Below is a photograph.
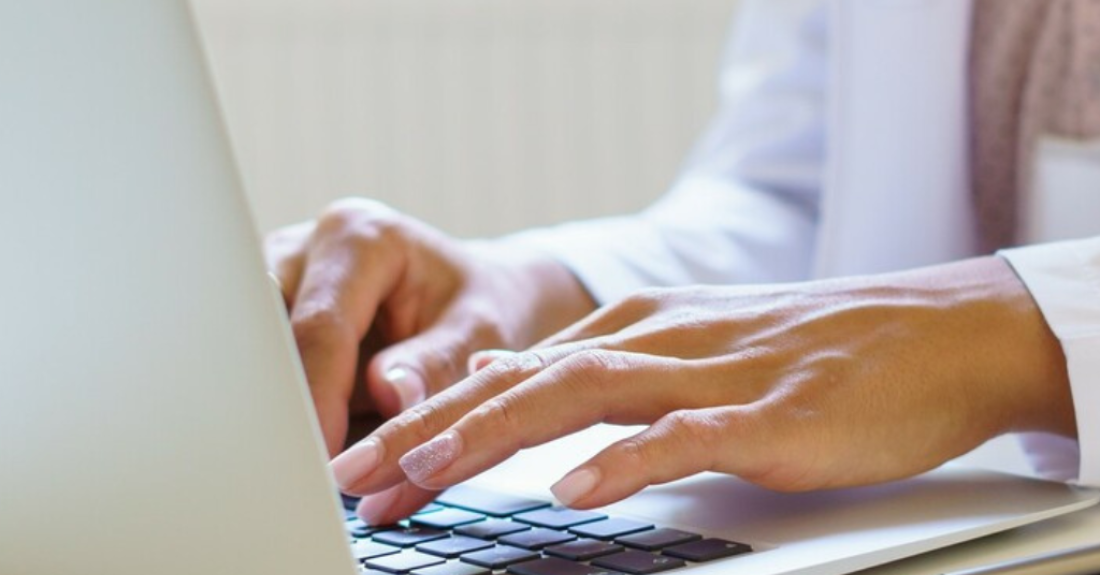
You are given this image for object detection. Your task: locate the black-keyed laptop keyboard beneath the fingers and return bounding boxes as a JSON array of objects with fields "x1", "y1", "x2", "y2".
[{"x1": 344, "y1": 486, "x2": 752, "y2": 575}]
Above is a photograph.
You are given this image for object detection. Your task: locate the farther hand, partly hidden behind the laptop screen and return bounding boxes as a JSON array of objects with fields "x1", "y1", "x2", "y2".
[{"x1": 265, "y1": 199, "x2": 595, "y2": 456}]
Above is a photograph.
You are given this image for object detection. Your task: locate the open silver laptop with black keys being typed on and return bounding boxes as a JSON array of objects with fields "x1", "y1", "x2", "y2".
[{"x1": 0, "y1": 0, "x2": 1098, "y2": 575}]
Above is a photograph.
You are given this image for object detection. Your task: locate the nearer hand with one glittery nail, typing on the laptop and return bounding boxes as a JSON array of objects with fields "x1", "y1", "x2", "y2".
[{"x1": 332, "y1": 257, "x2": 1076, "y2": 523}]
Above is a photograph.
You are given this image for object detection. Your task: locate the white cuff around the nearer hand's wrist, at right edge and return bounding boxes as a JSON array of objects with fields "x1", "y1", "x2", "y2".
[{"x1": 1000, "y1": 237, "x2": 1100, "y2": 487}]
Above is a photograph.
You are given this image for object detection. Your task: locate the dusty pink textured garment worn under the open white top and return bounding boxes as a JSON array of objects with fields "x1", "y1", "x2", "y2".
[{"x1": 970, "y1": 0, "x2": 1100, "y2": 251}]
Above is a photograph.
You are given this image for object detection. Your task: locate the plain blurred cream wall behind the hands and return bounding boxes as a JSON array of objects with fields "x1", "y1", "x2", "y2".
[{"x1": 195, "y1": 0, "x2": 735, "y2": 236}]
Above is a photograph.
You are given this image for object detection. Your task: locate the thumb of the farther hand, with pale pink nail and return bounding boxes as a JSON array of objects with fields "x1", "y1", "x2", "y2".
[{"x1": 366, "y1": 308, "x2": 501, "y2": 417}]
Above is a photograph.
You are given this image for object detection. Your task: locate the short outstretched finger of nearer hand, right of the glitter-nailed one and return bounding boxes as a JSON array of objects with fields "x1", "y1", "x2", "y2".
[{"x1": 550, "y1": 407, "x2": 761, "y2": 509}]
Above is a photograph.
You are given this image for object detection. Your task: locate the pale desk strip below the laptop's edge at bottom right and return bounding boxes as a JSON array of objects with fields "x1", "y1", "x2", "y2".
[{"x1": 860, "y1": 506, "x2": 1100, "y2": 575}]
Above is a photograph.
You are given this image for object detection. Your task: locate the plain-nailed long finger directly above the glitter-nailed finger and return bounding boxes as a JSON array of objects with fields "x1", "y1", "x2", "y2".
[{"x1": 332, "y1": 349, "x2": 568, "y2": 495}]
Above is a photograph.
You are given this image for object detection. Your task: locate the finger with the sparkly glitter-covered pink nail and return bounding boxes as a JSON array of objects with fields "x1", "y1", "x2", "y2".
[{"x1": 400, "y1": 350, "x2": 717, "y2": 489}]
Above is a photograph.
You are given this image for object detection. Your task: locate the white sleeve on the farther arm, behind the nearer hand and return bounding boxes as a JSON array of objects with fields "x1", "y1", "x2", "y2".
[{"x1": 509, "y1": 0, "x2": 828, "y2": 302}]
